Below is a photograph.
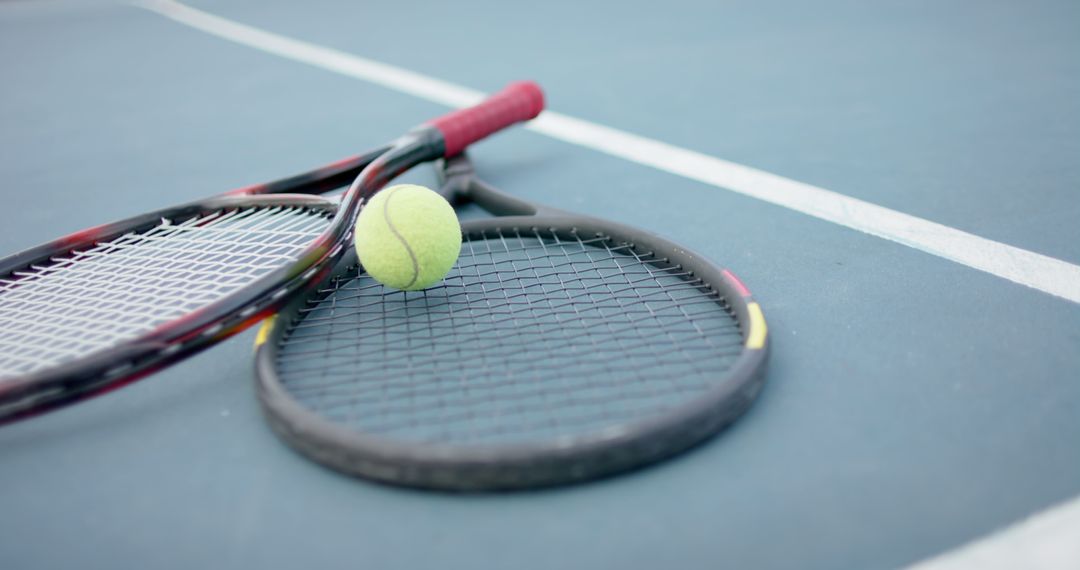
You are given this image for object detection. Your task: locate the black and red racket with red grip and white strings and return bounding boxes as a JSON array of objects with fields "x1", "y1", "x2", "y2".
[{"x1": 0, "y1": 82, "x2": 543, "y2": 423}]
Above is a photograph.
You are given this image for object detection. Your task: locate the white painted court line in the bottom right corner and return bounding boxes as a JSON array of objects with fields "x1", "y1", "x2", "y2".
[{"x1": 907, "y1": 499, "x2": 1080, "y2": 570}]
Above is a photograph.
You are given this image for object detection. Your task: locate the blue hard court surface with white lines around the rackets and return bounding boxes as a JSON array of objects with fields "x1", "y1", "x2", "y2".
[{"x1": 0, "y1": 0, "x2": 1080, "y2": 570}]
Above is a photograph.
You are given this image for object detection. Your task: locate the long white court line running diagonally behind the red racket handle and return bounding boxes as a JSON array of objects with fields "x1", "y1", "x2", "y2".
[{"x1": 134, "y1": 0, "x2": 1080, "y2": 303}]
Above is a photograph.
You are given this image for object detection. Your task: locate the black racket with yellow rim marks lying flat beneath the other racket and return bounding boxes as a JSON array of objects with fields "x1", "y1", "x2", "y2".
[{"x1": 256, "y1": 151, "x2": 768, "y2": 490}]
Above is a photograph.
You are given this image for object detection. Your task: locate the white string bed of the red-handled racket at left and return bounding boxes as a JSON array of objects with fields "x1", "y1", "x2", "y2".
[{"x1": 0, "y1": 206, "x2": 328, "y2": 378}]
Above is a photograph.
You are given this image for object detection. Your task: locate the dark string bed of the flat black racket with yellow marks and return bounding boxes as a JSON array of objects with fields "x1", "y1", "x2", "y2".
[{"x1": 276, "y1": 230, "x2": 742, "y2": 444}]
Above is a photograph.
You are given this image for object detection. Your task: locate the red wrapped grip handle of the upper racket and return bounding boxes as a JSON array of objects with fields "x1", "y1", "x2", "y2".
[{"x1": 428, "y1": 81, "x2": 543, "y2": 158}]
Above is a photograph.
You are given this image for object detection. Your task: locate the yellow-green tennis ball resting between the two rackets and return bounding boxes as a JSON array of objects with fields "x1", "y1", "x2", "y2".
[{"x1": 354, "y1": 185, "x2": 461, "y2": 290}]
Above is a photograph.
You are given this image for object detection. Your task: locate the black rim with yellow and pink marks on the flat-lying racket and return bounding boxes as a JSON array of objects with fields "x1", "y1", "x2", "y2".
[{"x1": 255, "y1": 215, "x2": 769, "y2": 491}]
